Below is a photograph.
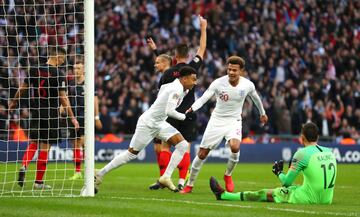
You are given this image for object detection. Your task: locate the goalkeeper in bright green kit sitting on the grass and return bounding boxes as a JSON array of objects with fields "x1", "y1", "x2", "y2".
[{"x1": 210, "y1": 122, "x2": 337, "y2": 204}]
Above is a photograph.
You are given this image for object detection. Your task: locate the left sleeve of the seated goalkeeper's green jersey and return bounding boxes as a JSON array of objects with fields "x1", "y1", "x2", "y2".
[{"x1": 279, "y1": 149, "x2": 308, "y2": 187}]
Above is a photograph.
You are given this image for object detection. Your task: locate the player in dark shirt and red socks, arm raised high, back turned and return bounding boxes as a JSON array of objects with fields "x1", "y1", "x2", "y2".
[{"x1": 148, "y1": 16, "x2": 207, "y2": 190}]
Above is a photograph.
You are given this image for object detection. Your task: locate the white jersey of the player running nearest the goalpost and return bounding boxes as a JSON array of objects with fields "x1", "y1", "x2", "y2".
[{"x1": 139, "y1": 79, "x2": 189, "y2": 127}]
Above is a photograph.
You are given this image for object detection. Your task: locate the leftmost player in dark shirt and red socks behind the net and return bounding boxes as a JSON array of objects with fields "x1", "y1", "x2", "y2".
[{"x1": 9, "y1": 47, "x2": 79, "y2": 189}]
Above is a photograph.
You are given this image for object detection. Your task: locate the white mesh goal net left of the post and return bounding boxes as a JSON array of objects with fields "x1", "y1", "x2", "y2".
[{"x1": 0, "y1": 0, "x2": 93, "y2": 197}]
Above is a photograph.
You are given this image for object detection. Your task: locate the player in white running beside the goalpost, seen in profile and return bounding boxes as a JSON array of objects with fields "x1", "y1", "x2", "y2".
[{"x1": 95, "y1": 66, "x2": 196, "y2": 192}]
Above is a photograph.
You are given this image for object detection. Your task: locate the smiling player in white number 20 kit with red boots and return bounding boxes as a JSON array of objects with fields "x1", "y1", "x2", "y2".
[{"x1": 180, "y1": 56, "x2": 268, "y2": 193}]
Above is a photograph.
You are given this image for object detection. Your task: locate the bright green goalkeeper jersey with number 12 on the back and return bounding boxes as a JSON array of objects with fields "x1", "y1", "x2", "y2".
[{"x1": 279, "y1": 145, "x2": 337, "y2": 204}]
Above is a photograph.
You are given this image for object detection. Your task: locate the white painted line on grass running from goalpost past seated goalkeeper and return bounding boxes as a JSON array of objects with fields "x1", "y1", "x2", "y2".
[{"x1": 101, "y1": 196, "x2": 358, "y2": 216}]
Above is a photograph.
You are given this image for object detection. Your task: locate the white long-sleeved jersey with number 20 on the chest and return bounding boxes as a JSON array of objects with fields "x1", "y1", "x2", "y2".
[{"x1": 191, "y1": 75, "x2": 265, "y2": 119}]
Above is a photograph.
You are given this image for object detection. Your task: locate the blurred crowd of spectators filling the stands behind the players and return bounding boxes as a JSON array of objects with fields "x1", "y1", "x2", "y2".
[{"x1": 0, "y1": 0, "x2": 360, "y2": 143}]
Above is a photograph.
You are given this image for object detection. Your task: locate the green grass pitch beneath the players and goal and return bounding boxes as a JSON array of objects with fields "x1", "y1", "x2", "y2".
[{"x1": 0, "y1": 163, "x2": 360, "y2": 217}]
